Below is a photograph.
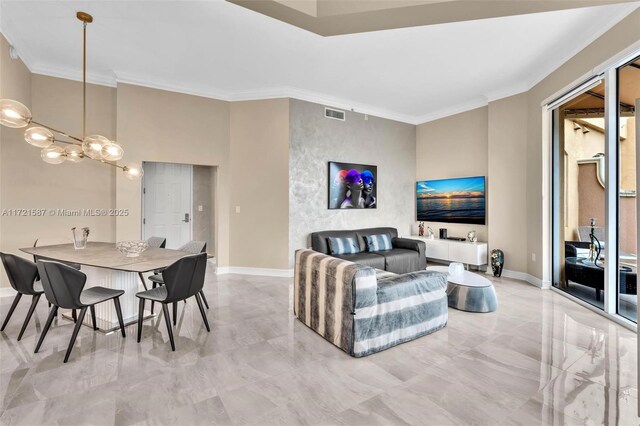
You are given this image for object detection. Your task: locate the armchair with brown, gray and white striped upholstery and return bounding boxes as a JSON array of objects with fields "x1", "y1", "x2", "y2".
[{"x1": 294, "y1": 250, "x2": 448, "y2": 357}]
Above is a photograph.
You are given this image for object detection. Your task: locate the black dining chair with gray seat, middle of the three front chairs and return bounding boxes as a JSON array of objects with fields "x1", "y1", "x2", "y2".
[{"x1": 34, "y1": 260, "x2": 126, "y2": 362}]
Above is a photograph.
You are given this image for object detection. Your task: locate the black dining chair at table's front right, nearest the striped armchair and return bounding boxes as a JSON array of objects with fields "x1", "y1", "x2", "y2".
[{"x1": 136, "y1": 253, "x2": 211, "y2": 351}]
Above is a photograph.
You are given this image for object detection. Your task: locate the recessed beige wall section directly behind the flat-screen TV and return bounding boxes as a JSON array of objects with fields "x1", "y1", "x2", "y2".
[{"x1": 414, "y1": 107, "x2": 493, "y2": 241}]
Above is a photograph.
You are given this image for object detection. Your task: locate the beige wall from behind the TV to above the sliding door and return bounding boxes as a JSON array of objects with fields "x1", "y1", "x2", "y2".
[{"x1": 416, "y1": 10, "x2": 640, "y2": 280}]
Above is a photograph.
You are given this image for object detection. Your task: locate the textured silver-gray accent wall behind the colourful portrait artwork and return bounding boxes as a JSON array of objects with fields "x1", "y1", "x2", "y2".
[{"x1": 289, "y1": 99, "x2": 416, "y2": 266}]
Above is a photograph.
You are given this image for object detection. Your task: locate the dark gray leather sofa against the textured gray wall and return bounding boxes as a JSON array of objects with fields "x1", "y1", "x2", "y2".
[{"x1": 311, "y1": 228, "x2": 427, "y2": 274}]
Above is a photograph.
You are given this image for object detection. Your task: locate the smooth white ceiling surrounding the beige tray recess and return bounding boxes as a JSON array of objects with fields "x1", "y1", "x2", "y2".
[{"x1": 0, "y1": 1, "x2": 639, "y2": 124}]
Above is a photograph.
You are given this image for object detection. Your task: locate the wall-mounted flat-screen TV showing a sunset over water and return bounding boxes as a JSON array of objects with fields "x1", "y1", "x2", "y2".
[{"x1": 416, "y1": 176, "x2": 486, "y2": 225}]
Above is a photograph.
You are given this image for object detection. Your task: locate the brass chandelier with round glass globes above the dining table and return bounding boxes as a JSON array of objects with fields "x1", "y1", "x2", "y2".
[{"x1": 0, "y1": 12, "x2": 143, "y2": 180}]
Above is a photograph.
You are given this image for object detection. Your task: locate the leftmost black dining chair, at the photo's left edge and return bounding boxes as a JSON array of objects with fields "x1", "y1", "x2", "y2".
[{"x1": 0, "y1": 253, "x2": 44, "y2": 340}]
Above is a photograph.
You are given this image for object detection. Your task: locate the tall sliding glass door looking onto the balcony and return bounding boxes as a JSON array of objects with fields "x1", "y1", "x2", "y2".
[{"x1": 550, "y1": 58, "x2": 640, "y2": 322}]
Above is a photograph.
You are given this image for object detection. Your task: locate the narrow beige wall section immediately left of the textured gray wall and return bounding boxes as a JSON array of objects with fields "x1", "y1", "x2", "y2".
[{"x1": 229, "y1": 99, "x2": 289, "y2": 269}]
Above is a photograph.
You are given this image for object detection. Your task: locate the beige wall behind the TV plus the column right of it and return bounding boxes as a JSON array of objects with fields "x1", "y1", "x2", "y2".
[{"x1": 416, "y1": 94, "x2": 527, "y2": 273}]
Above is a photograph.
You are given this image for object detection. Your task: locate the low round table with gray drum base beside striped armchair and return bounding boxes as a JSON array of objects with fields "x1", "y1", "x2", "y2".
[{"x1": 427, "y1": 266, "x2": 498, "y2": 312}]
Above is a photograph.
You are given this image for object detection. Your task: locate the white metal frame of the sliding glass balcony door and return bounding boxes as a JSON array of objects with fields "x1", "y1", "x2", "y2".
[{"x1": 542, "y1": 50, "x2": 640, "y2": 332}]
